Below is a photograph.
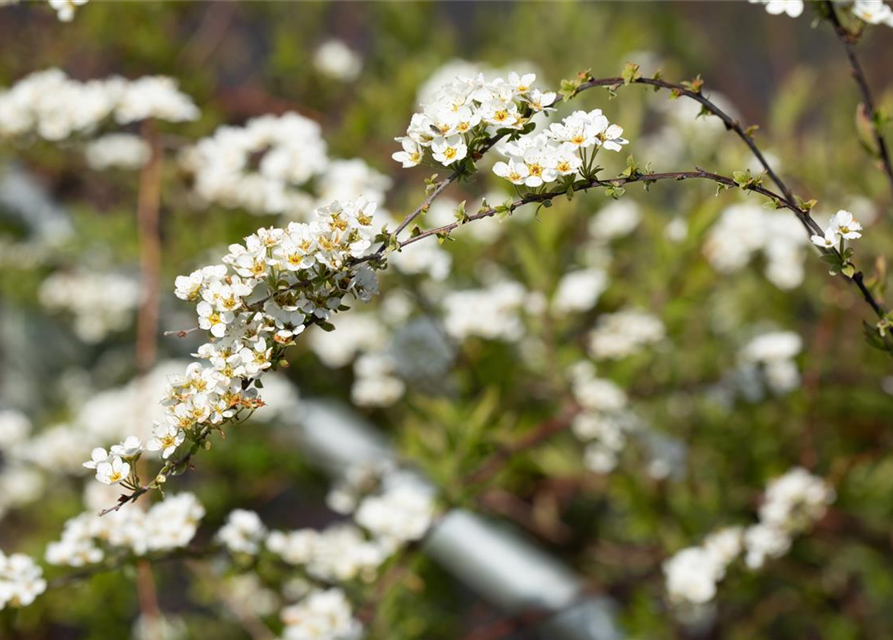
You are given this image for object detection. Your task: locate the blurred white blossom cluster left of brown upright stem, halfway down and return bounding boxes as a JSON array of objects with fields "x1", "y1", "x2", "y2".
[{"x1": 38, "y1": 270, "x2": 140, "y2": 343}]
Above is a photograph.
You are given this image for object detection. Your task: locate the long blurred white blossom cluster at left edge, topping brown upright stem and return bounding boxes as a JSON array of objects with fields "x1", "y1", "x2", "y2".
[{"x1": 0, "y1": 69, "x2": 199, "y2": 141}]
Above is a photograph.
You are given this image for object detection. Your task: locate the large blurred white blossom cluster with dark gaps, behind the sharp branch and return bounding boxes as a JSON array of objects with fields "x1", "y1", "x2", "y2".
[{"x1": 182, "y1": 112, "x2": 390, "y2": 219}]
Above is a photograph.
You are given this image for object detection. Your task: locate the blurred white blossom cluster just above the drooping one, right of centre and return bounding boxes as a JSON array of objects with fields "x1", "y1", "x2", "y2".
[{"x1": 588, "y1": 309, "x2": 666, "y2": 360}]
